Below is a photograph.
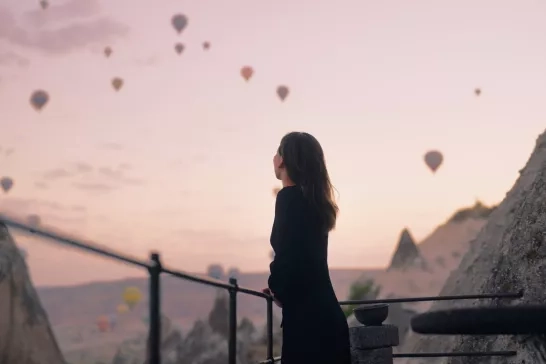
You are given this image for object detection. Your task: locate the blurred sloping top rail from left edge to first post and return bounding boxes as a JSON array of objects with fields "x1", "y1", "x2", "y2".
[{"x1": 0, "y1": 215, "x2": 150, "y2": 268}]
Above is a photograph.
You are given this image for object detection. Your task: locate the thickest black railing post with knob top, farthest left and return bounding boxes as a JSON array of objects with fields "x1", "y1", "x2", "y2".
[{"x1": 148, "y1": 253, "x2": 161, "y2": 364}]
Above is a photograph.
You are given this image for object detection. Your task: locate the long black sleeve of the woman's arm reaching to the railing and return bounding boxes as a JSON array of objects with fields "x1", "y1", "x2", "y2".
[{"x1": 268, "y1": 191, "x2": 304, "y2": 303}]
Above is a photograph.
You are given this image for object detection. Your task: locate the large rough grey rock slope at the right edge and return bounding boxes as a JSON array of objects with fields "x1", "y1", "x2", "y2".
[{"x1": 403, "y1": 133, "x2": 546, "y2": 364}]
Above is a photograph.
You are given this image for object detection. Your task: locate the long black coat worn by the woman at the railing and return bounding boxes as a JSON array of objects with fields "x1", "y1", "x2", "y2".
[{"x1": 268, "y1": 186, "x2": 351, "y2": 364}]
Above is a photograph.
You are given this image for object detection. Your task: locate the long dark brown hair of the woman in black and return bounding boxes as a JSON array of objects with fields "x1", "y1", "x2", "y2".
[{"x1": 278, "y1": 132, "x2": 339, "y2": 231}]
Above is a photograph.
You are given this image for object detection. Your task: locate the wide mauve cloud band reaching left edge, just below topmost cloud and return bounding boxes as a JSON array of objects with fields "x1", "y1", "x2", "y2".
[{"x1": 0, "y1": 5, "x2": 129, "y2": 53}]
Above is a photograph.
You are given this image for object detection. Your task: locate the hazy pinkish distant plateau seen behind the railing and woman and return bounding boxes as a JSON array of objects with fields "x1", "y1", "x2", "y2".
[{"x1": 38, "y1": 269, "x2": 379, "y2": 328}]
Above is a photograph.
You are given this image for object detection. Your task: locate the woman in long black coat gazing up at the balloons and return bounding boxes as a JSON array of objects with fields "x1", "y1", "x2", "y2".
[{"x1": 264, "y1": 132, "x2": 351, "y2": 364}]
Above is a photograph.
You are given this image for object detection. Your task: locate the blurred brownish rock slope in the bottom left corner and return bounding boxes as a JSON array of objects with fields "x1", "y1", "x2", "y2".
[{"x1": 0, "y1": 223, "x2": 65, "y2": 364}]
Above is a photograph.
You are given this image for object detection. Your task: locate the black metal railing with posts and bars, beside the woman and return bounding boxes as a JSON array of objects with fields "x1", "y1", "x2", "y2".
[{"x1": 0, "y1": 215, "x2": 523, "y2": 364}]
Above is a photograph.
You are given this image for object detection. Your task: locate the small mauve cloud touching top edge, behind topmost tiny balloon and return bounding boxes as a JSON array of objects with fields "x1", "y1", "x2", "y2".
[{"x1": 25, "y1": 0, "x2": 100, "y2": 27}]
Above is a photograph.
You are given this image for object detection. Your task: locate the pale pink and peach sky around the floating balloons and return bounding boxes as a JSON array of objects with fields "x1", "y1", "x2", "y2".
[{"x1": 0, "y1": 0, "x2": 546, "y2": 284}]
